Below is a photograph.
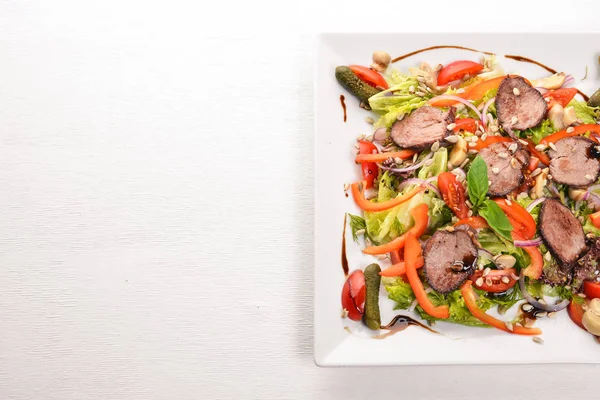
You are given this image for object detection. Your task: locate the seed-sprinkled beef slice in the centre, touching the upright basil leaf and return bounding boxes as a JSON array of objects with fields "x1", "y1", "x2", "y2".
[{"x1": 479, "y1": 142, "x2": 529, "y2": 196}]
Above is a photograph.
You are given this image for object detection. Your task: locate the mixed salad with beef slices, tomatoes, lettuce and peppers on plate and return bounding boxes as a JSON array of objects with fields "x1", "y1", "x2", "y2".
[{"x1": 335, "y1": 51, "x2": 600, "y2": 342}]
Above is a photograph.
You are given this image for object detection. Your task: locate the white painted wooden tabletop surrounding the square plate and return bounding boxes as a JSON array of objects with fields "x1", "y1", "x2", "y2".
[{"x1": 0, "y1": 0, "x2": 598, "y2": 400}]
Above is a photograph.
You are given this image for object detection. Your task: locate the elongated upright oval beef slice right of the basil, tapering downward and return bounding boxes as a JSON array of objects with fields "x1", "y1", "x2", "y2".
[{"x1": 538, "y1": 199, "x2": 586, "y2": 271}]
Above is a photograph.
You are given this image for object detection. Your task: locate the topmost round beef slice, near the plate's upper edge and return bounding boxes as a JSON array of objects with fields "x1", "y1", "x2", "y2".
[{"x1": 496, "y1": 76, "x2": 548, "y2": 138}]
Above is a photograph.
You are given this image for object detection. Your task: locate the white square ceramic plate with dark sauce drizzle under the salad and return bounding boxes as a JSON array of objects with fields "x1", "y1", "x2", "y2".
[{"x1": 315, "y1": 33, "x2": 600, "y2": 366}]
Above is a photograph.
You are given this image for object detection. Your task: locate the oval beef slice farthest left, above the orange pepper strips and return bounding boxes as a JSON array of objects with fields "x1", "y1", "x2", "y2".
[{"x1": 391, "y1": 106, "x2": 455, "y2": 150}]
